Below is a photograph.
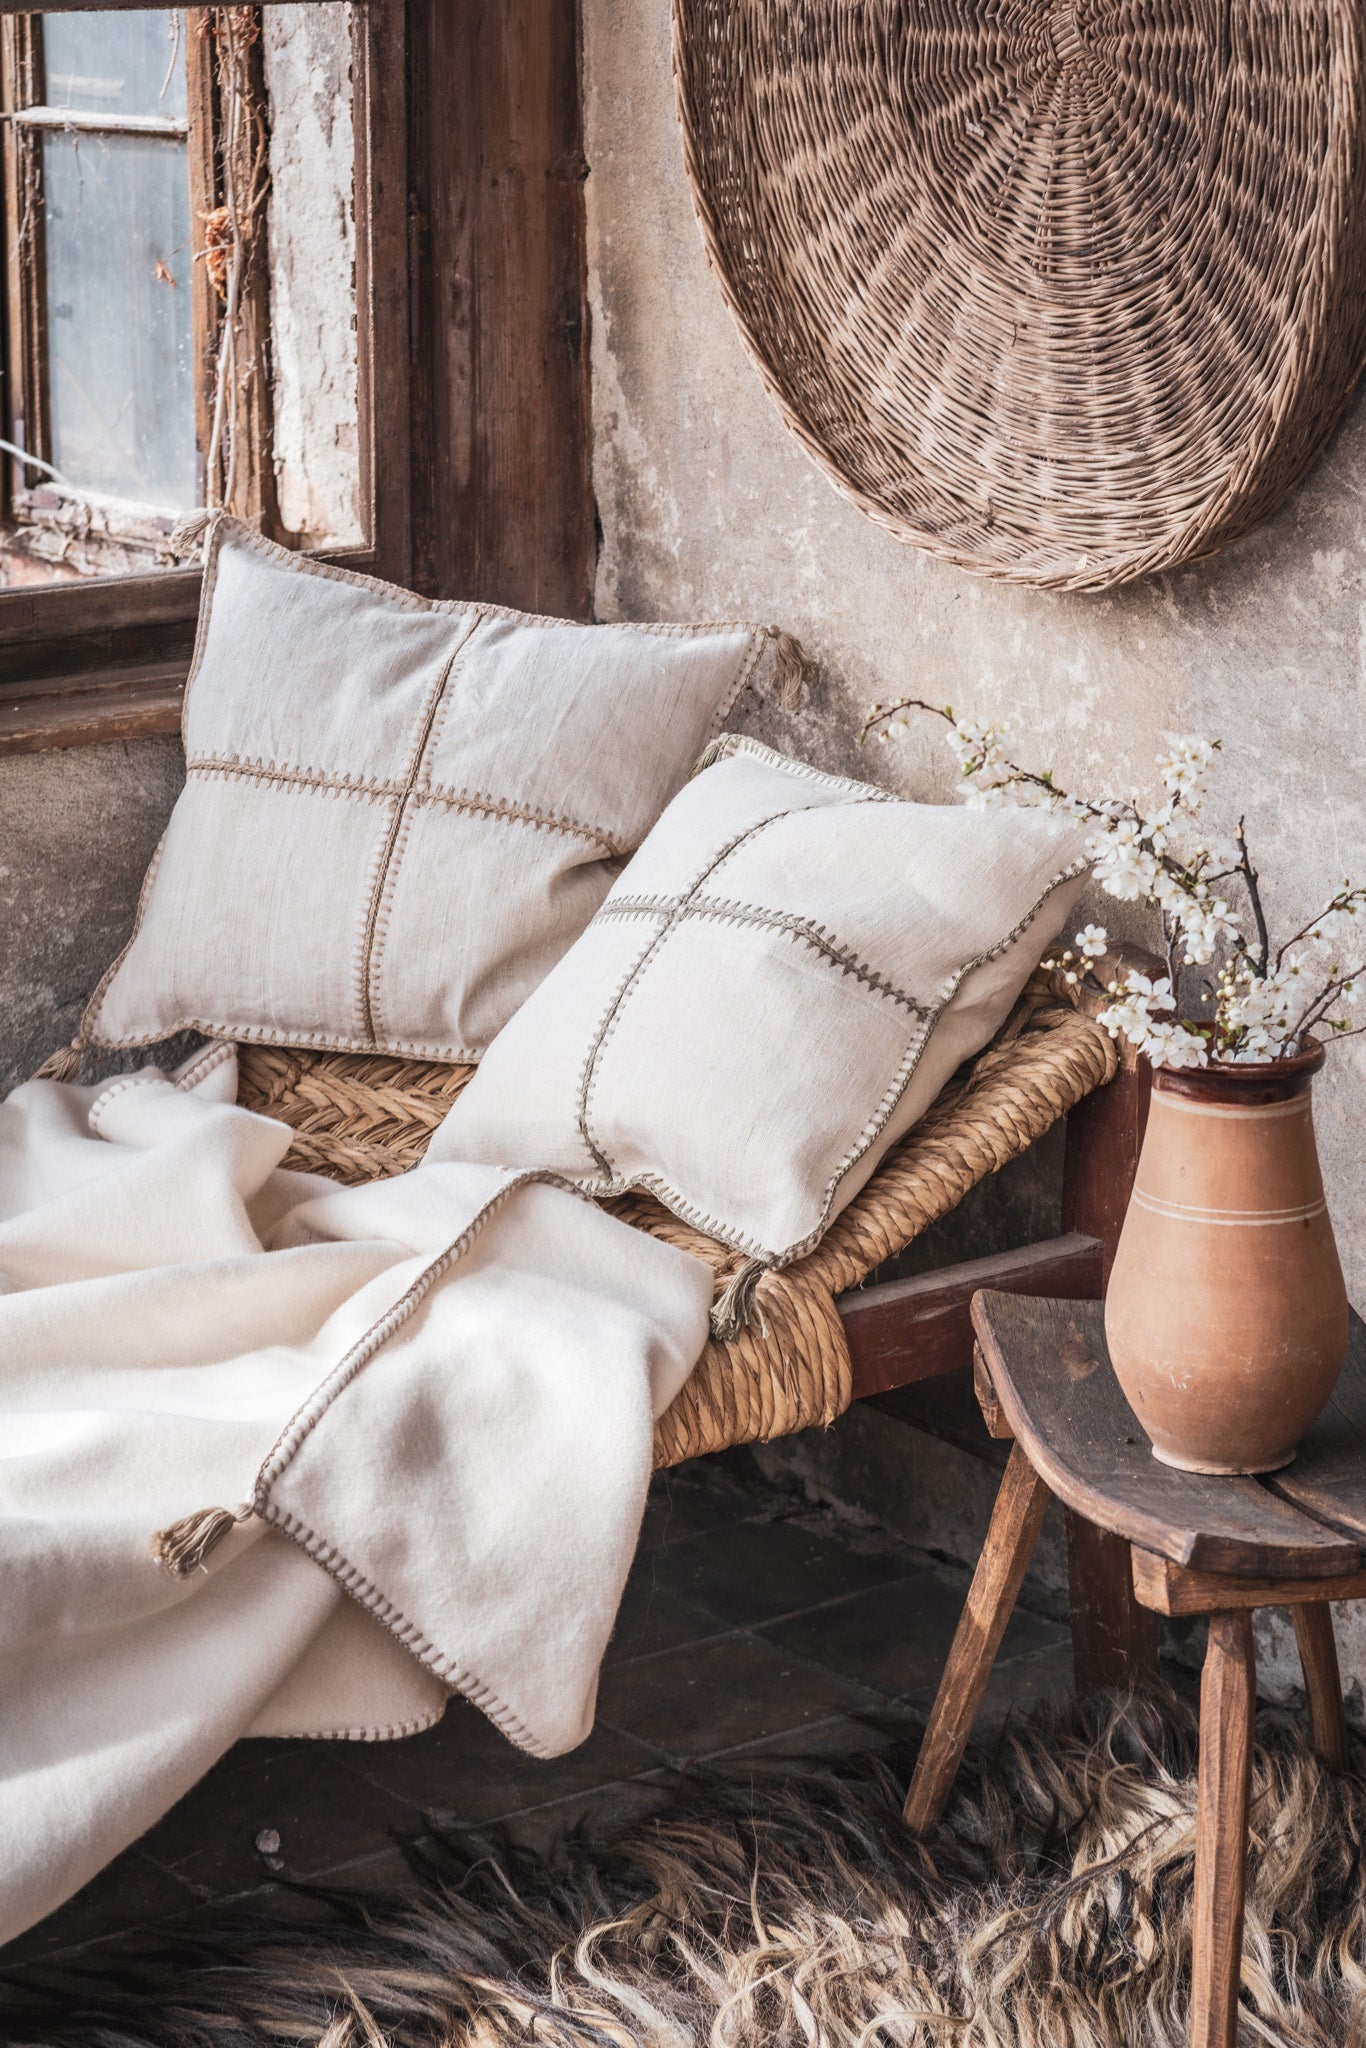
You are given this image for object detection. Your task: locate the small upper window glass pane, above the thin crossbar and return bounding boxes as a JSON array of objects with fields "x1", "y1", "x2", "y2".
[{"x1": 43, "y1": 8, "x2": 184, "y2": 121}]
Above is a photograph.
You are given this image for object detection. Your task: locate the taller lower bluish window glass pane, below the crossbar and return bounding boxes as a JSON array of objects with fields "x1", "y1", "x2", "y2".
[{"x1": 43, "y1": 130, "x2": 195, "y2": 512}]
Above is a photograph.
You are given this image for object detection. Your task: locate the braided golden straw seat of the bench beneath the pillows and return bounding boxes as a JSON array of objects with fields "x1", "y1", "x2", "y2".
[{"x1": 238, "y1": 993, "x2": 1116, "y2": 1464}]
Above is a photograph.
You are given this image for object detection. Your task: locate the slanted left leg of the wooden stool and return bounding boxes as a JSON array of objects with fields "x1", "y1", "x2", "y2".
[{"x1": 905, "y1": 1444, "x2": 1049, "y2": 1835}]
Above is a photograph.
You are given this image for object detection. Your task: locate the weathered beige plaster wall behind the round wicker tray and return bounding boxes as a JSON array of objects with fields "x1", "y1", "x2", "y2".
[{"x1": 586, "y1": 0, "x2": 1366, "y2": 1706}]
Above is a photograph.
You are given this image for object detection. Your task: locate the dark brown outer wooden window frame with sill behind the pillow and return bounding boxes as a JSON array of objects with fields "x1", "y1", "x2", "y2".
[{"x1": 0, "y1": 0, "x2": 412, "y2": 754}]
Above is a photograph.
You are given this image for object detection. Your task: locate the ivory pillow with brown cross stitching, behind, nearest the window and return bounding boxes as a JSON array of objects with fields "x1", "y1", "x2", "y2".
[{"x1": 76, "y1": 518, "x2": 801, "y2": 1061}]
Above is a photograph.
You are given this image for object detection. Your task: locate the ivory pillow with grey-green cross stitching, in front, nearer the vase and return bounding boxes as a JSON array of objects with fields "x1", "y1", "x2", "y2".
[{"x1": 428, "y1": 735, "x2": 1087, "y2": 1266}]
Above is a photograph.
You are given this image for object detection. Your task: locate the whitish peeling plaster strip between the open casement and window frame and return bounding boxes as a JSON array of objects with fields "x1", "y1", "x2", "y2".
[{"x1": 262, "y1": 0, "x2": 362, "y2": 547}]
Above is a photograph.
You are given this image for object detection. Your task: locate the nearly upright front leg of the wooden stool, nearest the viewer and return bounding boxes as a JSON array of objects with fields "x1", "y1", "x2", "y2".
[{"x1": 1190, "y1": 1610, "x2": 1257, "y2": 2048}]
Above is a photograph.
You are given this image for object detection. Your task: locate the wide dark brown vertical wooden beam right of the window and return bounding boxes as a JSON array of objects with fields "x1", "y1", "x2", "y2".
[{"x1": 408, "y1": 0, "x2": 596, "y2": 618}]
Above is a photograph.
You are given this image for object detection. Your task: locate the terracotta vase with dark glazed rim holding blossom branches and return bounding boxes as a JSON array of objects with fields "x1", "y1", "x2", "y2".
[{"x1": 1106, "y1": 1044, "x2": 1348, "y2": 1473}]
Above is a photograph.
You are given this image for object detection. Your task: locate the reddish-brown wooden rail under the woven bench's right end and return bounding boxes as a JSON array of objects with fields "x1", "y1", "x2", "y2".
[{"x1": 838, "y1": 1231, "x2": 1102, "y2": 1401}]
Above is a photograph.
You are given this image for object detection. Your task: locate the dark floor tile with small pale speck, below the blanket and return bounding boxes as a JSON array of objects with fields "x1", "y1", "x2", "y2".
[{"x1": 139, "y1": 1741, "x2": 420, "y2": 1896}]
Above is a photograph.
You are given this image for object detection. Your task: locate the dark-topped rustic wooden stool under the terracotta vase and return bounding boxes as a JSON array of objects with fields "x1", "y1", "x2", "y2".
[{"x1": 905, "y1": 1294, "x2": 1366, "y2": 2048}]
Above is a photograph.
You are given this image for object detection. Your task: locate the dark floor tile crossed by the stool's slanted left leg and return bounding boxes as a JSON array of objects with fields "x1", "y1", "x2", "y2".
[{"x1": 756, "y1": 1565, "x2": 1069, "y2": 1700}]
